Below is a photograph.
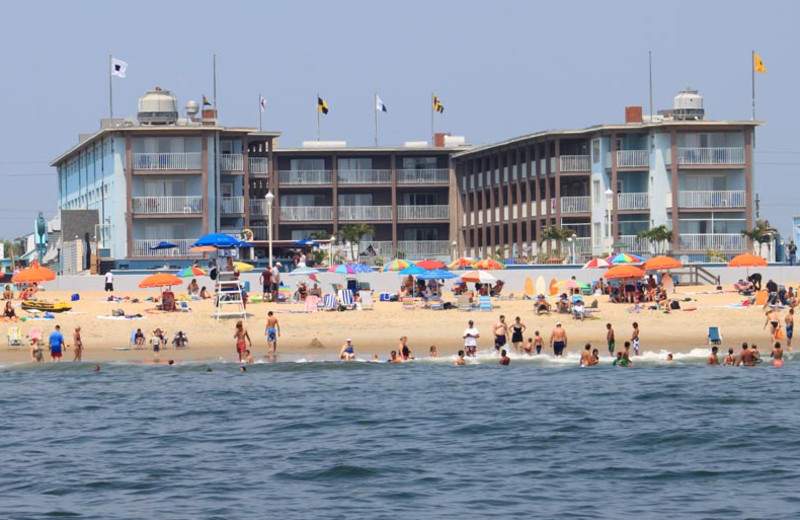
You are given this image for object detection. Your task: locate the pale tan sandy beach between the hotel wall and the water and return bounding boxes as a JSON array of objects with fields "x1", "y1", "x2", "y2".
[{"x1": 0, "y1": 286, "x2": 785, "y2": 363}]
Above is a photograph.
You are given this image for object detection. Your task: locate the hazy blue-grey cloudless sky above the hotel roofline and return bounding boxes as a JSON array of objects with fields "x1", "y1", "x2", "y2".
[{"x1": 0, "y1": 0, "x2": 800, "y2": 238}]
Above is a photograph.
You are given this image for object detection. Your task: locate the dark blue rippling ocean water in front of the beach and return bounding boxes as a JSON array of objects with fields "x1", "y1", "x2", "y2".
[{"x1": 0, "y1": 350, "x2": 800, "y2": 519}]
